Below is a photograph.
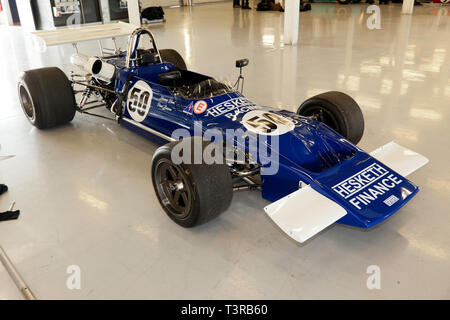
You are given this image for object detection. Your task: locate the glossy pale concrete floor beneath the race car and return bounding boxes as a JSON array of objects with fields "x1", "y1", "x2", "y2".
[{"x1": 0, "y1": 3, "x2": 450, "y2": 299}]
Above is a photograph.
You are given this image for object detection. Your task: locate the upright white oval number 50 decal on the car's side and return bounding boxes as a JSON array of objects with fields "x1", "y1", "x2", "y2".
[{"x1": 127, "y1": 80, "x2": 153, "y2": 122}]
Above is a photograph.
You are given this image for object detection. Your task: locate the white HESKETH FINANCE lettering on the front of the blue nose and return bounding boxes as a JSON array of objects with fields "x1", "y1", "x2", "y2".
[{"x1": 332, "y1": 163, "x2": 403, "y2": 210}]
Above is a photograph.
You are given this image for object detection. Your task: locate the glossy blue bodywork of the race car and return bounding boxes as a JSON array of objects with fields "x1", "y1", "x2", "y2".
[{"x1": 108, "y1": 56, "x2": 418, "y2": 228}]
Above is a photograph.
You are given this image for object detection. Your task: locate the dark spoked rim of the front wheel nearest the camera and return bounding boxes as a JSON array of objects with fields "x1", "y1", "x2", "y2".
[{"x1": 155, "y1": 159, "x2": 192, "y2": 219}]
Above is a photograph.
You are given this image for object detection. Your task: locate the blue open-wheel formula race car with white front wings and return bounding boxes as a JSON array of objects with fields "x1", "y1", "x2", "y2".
[{"x1": 18, "y1": 25, "x2": 428, "y2": 242}]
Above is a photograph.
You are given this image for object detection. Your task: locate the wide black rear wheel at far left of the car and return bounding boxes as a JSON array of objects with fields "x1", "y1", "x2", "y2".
[{"x1": 18, "y1": 67, "x2": 75, "y2": 129}]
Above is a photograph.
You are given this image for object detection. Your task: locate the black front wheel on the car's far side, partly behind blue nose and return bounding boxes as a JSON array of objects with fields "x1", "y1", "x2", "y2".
[{"x1": 297, "y1": 91, "x2": 364, "y2": 144}]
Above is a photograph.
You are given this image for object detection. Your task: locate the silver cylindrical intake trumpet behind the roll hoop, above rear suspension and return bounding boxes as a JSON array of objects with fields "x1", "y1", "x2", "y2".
[{"x1": 70, "y1": 53, "x2": 116, "y2": 83}]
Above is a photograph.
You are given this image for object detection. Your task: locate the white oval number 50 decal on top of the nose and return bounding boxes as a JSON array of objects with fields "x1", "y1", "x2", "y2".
[{"x1": 242, "y1": 110, "x2": 295, "y2": 136}]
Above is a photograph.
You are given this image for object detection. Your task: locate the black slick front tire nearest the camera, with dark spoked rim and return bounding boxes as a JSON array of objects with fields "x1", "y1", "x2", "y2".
[{"x1": 152, "y1": 138, "x2": 233, "y2": 228}]
